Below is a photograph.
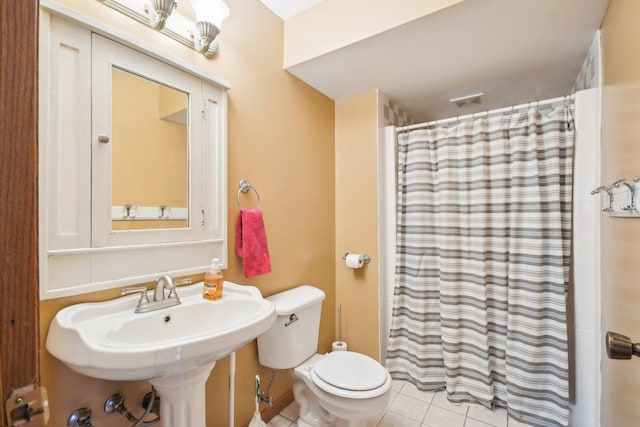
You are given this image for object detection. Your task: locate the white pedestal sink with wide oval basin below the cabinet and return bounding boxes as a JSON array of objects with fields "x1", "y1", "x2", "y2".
[{"x1": 46, "y1": 282, "x2": 276, "y2": 427}]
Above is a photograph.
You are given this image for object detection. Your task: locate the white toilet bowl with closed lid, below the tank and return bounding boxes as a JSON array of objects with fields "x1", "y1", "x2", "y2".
[{"x1": 290, "y1": 351, "x2": 391, "y2": 427}]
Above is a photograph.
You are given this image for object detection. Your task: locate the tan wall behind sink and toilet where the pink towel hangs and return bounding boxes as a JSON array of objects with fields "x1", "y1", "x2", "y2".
[{"x1": 41, "y1": 0, "x2": 336, "y2": 427}]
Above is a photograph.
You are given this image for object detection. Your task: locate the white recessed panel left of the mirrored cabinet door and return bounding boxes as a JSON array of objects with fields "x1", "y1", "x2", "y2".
[{"x1": 39, "y1": 15, "x2": 91, "y2": 250}]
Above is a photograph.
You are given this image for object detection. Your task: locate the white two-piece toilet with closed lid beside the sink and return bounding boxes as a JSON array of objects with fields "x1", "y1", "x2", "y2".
[{"x1": 258, "y1": 285, "x2": 391, "y2": 427}]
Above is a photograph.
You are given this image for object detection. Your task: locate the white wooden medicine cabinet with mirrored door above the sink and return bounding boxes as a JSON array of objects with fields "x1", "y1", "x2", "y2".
[{"x1": 39, "y1": 0, "x2": 229, "y2": 299}]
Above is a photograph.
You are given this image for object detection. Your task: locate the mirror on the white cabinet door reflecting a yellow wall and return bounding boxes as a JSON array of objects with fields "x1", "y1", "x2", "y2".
[{"x1": 111, "y1": 67, "x2": 189, "y2": 230}]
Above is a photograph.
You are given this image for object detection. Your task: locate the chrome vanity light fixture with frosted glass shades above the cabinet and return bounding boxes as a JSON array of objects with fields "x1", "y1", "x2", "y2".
[{"x1": 92, "y1": 0, "x2": 229, "y2": 58}]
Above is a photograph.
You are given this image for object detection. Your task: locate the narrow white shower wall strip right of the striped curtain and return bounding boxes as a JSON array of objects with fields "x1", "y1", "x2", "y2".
[{"x1": 568, "y1": 89, "x2": 601, "y2": 427}]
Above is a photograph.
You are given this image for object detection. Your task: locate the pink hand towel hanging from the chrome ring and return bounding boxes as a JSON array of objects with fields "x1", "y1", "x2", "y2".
[{"x1": 236, "y1": 209, "x2": 271, "y2": 277}]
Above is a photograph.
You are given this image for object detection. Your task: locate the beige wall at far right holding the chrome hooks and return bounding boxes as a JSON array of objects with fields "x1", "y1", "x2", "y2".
[{"x1": 601, "y1": 0, "x2": 640, "y2": 427}]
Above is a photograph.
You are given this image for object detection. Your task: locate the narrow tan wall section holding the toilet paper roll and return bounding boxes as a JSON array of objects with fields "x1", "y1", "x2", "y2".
[{"x1": 335, "y1": 91, "x2": 379, "y2": 359}]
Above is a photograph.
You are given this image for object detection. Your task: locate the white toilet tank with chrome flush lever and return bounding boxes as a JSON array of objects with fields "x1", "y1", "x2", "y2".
[{"x1": 258, "y1": 285, "x2": 325, "y2": 369}]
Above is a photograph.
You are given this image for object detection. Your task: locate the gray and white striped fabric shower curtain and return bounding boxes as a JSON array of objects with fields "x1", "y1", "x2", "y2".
[{"x1": 386, "y1": 106, "x2": 573, "y2": 427}]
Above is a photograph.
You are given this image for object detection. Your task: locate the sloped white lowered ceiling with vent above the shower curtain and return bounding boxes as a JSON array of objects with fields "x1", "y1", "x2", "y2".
[{"x1": 262, "y1": 0, "x2": 608, "y2": 122}]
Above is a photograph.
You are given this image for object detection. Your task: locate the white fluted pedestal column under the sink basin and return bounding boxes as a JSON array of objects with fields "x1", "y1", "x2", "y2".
[{"x1": 149, "y1": 362, "x2": 215, "y2": 427}]
